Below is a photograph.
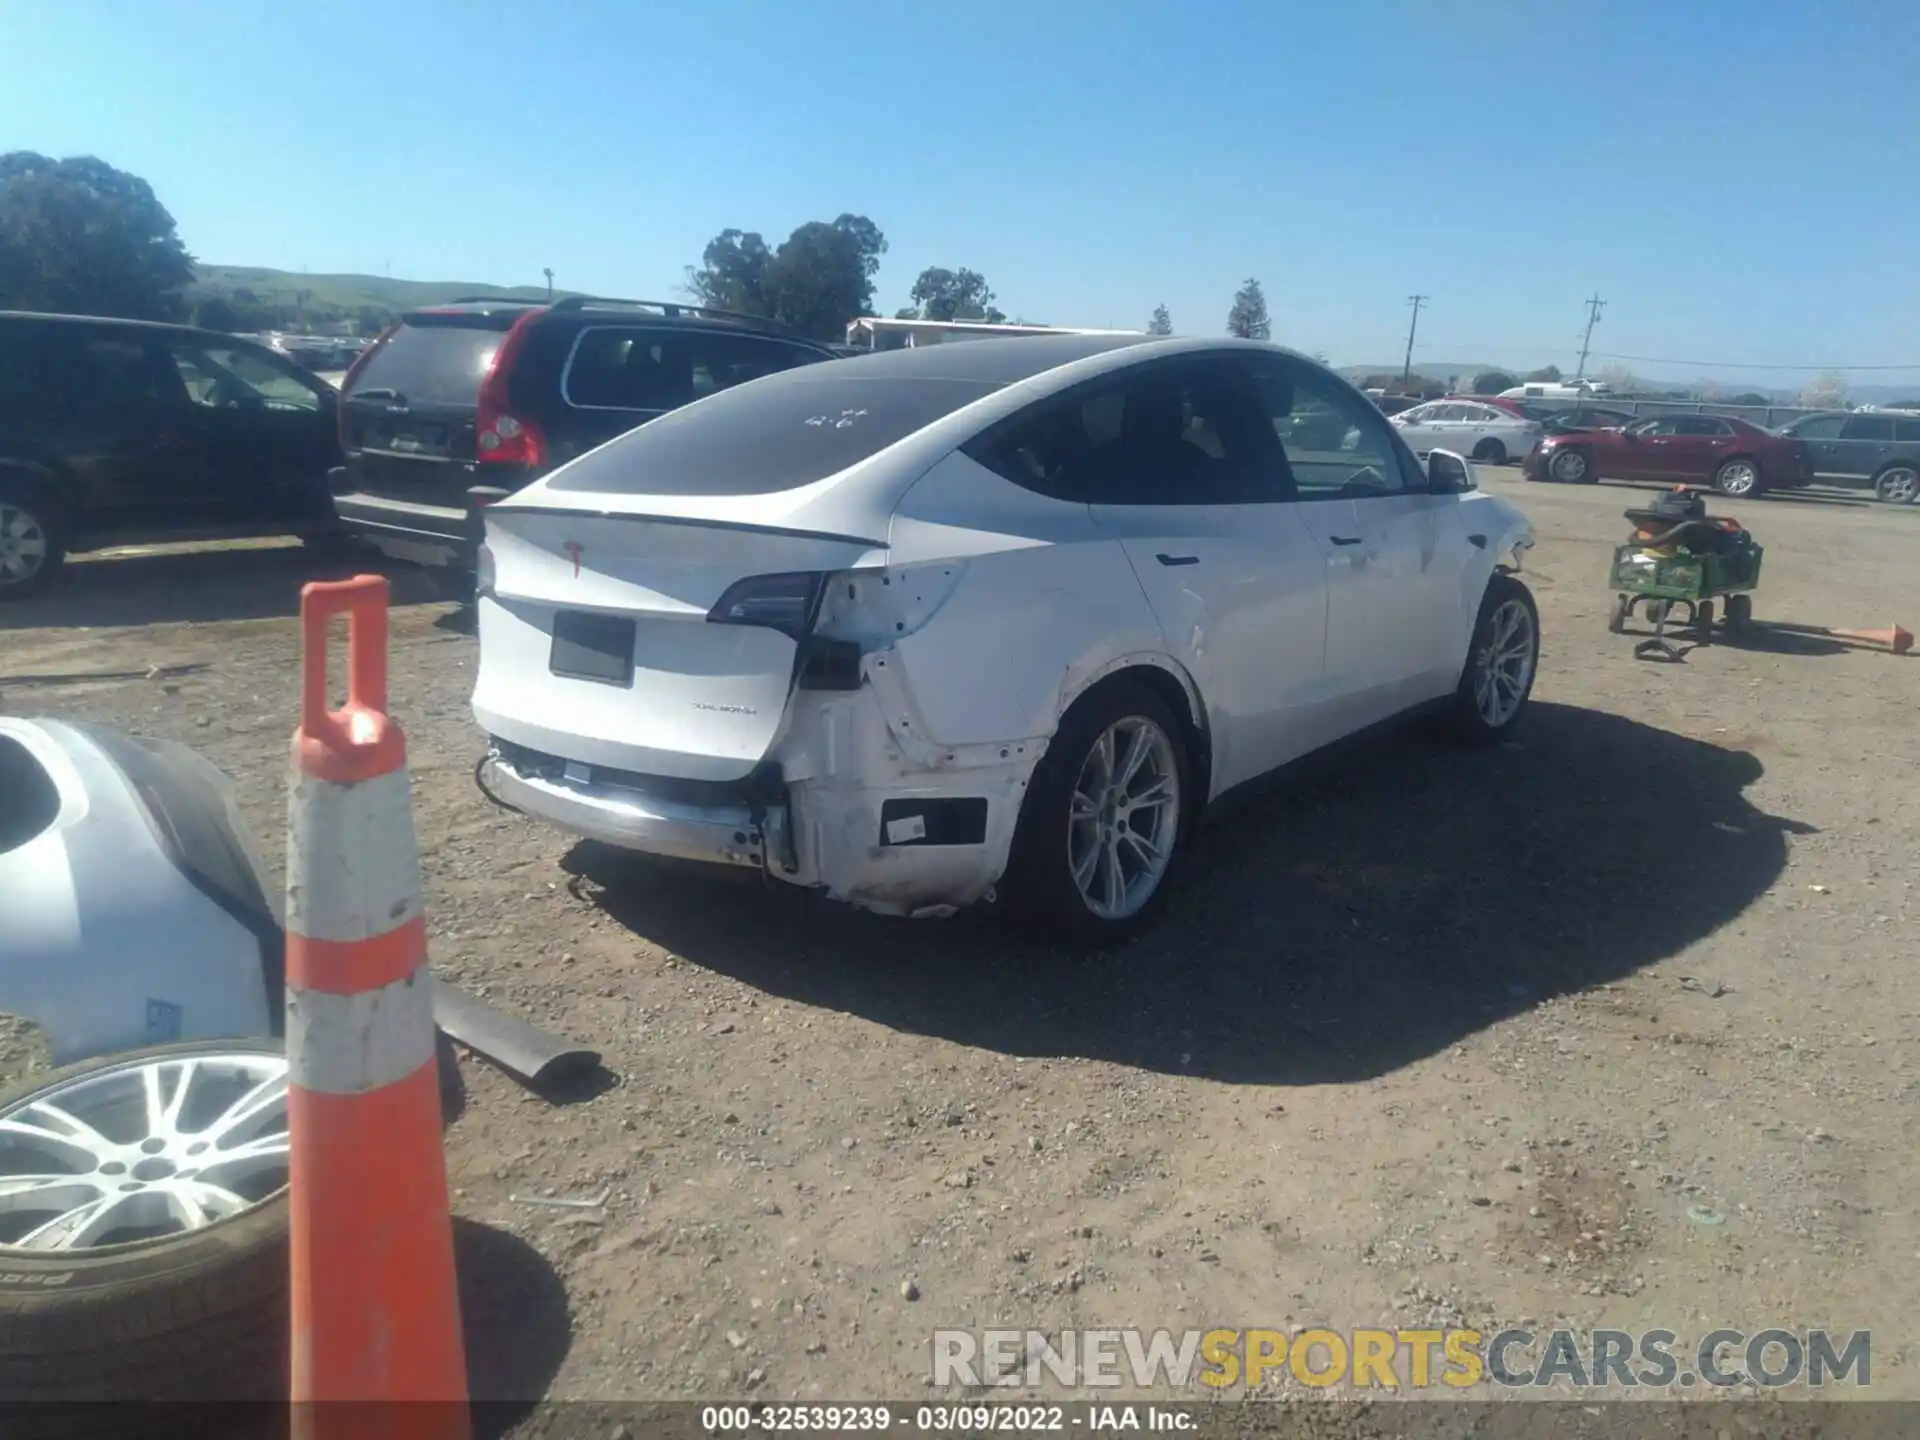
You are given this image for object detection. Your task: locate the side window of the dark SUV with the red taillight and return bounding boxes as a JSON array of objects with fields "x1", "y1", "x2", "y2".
[{"x1": 561, "y1": 324, "x2": 826, "y2": 411}]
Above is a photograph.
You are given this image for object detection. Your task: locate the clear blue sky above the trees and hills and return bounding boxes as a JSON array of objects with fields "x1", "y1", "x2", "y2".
[{"x1": 0, "y1": 0, "x2": 1920, "y2": 384}]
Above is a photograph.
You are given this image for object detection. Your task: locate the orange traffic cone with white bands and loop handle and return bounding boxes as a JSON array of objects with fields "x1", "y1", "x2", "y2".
[{"x1": 286, "y1": 576, "x2": 470, "y2": 1440}]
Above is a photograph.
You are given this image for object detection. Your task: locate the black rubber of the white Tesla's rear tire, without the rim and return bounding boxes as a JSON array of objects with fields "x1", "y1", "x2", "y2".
[{"x1": 998, "y1": 676, "x2": 1198, "y2": 945}]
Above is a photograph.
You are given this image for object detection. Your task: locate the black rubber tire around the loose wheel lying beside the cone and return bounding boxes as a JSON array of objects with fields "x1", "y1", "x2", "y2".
[{"x1": 0, "y1": 1041, "x2": 288, "y2": 1421}]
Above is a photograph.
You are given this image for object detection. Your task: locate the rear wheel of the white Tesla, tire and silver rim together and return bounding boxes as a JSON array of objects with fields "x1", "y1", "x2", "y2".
[{"x1": 1002, "y1": 678, "x2": 1194, "y2": 943}]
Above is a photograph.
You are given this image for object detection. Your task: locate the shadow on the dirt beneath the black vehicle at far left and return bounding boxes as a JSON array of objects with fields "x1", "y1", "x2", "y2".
[{"x1": 0, "y1": 545, "x2": 442, "y2": 630}]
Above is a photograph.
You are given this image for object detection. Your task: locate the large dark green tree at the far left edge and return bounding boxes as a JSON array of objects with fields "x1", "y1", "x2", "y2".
[{"x1": 0, "y1": 150, "x2": 194, "y2": 321}]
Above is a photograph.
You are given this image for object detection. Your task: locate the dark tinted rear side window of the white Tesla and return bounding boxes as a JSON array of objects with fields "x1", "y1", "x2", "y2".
[{"x1": 968, "y1": 361, "x2": 1274, "y2": 505}]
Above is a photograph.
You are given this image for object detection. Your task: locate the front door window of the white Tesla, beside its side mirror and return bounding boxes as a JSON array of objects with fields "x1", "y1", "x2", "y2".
[{"x1": 1248, "y1": 357, "x2": 1413, "y2": 499}]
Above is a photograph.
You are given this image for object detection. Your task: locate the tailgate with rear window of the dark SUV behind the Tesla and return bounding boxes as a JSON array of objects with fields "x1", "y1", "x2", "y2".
[{"x1": 340, "y1": 311, "x2": 516, "y2": 507}]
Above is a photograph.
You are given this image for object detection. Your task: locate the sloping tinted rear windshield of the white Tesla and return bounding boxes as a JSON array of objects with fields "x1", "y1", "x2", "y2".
[{"x1": 547, "y1": 372, "x2": 998, "y2": 495}]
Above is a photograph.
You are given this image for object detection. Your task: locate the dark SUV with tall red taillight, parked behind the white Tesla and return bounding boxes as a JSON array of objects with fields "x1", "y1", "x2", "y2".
[{"x1": 332, "y1": 296, "x2": 833, "y2": 572}]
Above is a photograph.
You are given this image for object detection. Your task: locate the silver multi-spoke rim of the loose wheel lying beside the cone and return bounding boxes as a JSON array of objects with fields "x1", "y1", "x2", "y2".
[{"x1": 0, "y1": 1052, "x2": 288, "y2": 1252}]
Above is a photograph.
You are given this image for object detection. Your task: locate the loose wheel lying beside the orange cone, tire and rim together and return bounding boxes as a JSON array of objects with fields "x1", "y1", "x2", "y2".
[{"x1": 0, "y1": 1041, "x2": 288, "y2": 1404}]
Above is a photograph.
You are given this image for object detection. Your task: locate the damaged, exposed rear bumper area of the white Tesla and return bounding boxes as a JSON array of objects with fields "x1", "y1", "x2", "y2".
[{"x1": 484, "y1": 668, "x2": 1046, "y2": 916}]
